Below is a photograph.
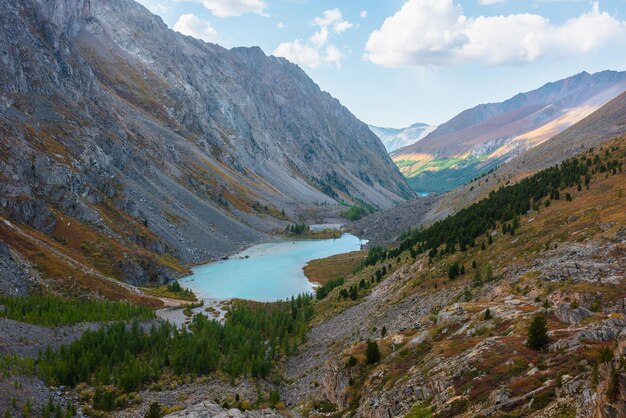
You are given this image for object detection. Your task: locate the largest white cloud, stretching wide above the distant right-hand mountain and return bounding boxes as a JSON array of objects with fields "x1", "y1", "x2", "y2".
[{"x1": 364, "y1": 0, "x2": 626, "y2": 67}]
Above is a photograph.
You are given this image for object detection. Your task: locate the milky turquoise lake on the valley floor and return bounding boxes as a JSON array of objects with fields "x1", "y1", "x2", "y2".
[{"x1": 180, "y1": 234, "x2": 365, "y2": 302}]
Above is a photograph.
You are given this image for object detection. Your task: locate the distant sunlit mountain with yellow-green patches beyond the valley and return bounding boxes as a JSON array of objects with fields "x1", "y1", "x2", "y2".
[{"x1": 391, "y1": 71, "x2": 626, "y2": 192}]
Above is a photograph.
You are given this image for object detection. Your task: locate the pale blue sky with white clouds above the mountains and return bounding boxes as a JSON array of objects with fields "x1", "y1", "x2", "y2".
[{"x1": 133, "y1": 0, "x2": 626, "y2": 128}]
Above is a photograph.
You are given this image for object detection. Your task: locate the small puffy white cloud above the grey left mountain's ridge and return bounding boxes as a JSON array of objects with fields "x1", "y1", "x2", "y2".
[{"x1": 273, "y1": 9, "x2": 354, "y2": 68}]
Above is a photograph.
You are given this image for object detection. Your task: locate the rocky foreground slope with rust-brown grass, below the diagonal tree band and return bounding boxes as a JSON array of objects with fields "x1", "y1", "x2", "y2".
[{"x1": 282, "y1": 138, "x2": 626, "y2": 417}]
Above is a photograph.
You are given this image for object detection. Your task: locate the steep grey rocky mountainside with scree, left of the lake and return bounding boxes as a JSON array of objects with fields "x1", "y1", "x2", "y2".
[{"x1": 0, "y1": 0, "x2": 412, "y2": 290}]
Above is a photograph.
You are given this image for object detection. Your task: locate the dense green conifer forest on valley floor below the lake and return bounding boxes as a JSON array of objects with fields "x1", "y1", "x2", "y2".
[{"x1": 37, "y1": 295, "x2": 313, "y2": 391}]
